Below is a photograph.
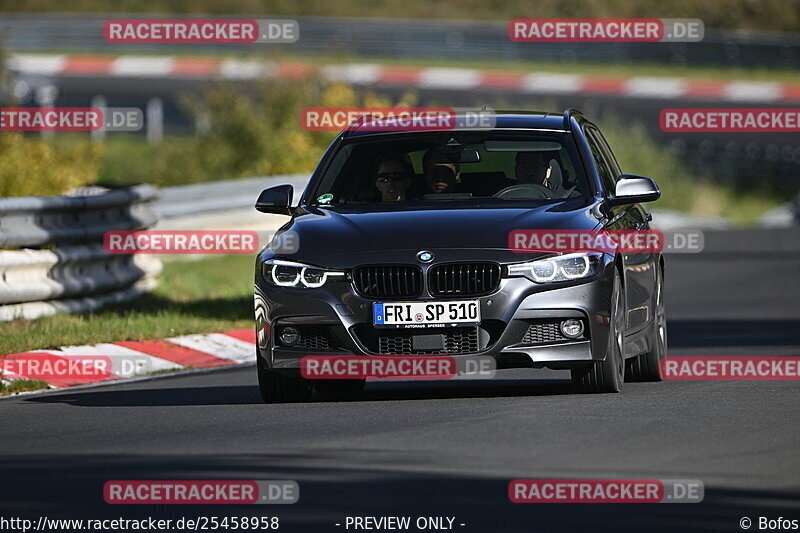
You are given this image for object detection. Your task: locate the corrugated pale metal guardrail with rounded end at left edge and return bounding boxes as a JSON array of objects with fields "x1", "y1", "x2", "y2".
[{"x1": 0, "y1": 185, "x2": 161, "y2": 321}]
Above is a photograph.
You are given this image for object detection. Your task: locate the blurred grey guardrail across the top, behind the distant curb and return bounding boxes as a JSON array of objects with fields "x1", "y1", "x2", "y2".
[{"x1": 0, "y1": 13, "x2": 800, "y2": 68}]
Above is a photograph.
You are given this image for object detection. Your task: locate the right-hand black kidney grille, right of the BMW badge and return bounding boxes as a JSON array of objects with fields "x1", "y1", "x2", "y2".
[{"x1": 428, "y1": 263, "x2": 500, "y2": 296}]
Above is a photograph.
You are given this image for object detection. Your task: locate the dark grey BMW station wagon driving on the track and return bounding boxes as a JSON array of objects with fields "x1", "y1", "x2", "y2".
[{"x1": 255, "y1": 110, "x2": 666, "y2": 402}]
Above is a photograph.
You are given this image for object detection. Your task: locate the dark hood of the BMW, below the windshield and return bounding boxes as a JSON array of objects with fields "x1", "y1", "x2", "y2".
[{"x1": 268, "y1": 199, "x2": 598, "y2": 263}]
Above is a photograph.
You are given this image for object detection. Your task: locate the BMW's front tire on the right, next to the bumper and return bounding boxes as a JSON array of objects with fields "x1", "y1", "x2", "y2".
[{"x1": 571, "y1": 269, "x2": 625, "y2": 393}]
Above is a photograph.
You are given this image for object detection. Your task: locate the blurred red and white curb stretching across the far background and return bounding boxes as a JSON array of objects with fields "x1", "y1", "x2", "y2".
[{"x1": 9, "y1": 54, "x2": 800, "y2": 102}]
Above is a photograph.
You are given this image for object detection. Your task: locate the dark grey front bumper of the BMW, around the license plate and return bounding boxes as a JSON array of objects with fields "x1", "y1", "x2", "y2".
[{"x1": 255, "y1": 256, "x2": 614, "y2": 369}]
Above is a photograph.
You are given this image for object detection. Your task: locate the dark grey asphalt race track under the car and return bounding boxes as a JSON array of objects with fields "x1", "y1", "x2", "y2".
[{"x1": 0, "y1": 230, "x2": 800, "y2": 532}]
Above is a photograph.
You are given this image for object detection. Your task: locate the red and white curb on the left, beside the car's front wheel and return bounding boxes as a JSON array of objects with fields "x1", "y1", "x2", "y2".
[{"x1": 0, "y1": 329, "x2": 256, "y2": 388}]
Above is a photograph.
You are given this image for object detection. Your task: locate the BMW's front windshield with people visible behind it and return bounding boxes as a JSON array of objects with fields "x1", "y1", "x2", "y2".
[{"x1": 309, "y1": 131, "x2": 590, "y2": 207}]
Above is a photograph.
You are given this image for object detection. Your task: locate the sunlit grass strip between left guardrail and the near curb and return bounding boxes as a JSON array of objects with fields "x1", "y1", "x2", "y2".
[{"x1": 0, "y1": 255, "x2": 255, "y2": 354}]
